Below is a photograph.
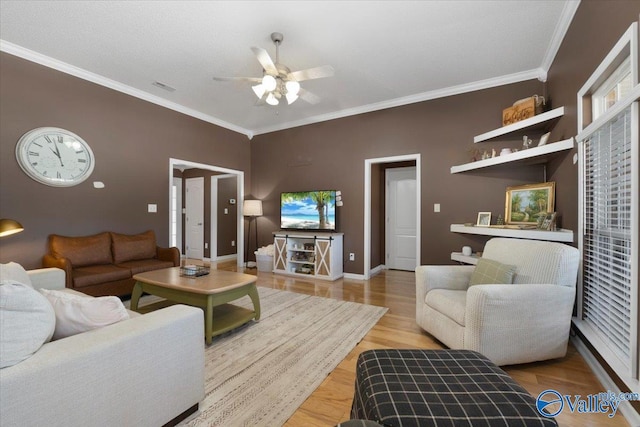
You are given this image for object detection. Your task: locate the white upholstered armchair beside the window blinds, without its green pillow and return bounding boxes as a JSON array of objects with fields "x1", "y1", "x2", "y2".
[{"x1": 416, "y1": 238, "x2": 579, "y2": 365}]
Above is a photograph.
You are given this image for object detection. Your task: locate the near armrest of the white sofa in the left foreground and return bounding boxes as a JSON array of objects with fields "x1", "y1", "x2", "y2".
[{"x1": 0, "y1": 305, "x2": 204, "y2": 426}]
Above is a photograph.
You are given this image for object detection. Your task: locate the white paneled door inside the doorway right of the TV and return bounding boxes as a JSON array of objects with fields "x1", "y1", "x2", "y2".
[{"x1": 385, "y1": 167, "x2": 417, "y2": 271}]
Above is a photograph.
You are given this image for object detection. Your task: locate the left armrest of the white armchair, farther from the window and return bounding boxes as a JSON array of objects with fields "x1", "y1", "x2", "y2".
[{"x1": 416, "y1": 265, "x2": 475, "y2": 319}]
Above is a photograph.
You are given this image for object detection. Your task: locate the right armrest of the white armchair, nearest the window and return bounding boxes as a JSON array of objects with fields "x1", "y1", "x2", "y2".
[{"x1": 464, "y1": 284, "x2": 576, "y2": 365}]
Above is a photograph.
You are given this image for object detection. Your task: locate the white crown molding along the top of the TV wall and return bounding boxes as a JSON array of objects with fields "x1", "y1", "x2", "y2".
[{"x1": 253, "y1": 68, "x2": 547, "y2": 135}]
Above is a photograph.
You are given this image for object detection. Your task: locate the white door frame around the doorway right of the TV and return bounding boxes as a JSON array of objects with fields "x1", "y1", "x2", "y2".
[{"x1": 363, "y1": 153, "x2": 422, "y2": 280}]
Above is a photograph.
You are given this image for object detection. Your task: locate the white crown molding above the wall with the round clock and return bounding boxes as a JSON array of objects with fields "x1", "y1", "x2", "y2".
[{"x1": 0, "y1": 39, "x2": 254, "y2": 139}]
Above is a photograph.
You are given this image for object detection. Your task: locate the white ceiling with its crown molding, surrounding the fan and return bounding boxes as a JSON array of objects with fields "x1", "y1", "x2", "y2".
[{"x1": 0, "y1": 0, "x2": 578, "y2": 137}]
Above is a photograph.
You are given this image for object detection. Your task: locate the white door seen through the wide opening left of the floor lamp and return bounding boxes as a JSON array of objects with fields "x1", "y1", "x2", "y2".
[{"x1": 185, "y1": 177, "x2": 204, "y2": 259}]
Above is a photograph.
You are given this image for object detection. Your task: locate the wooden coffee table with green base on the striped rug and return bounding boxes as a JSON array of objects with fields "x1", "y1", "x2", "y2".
[{"x1": 131, "y1": 267, "x2": 260, "y2": 344}]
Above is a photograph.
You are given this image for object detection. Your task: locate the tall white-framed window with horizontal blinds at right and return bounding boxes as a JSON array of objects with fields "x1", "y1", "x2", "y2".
[{"x1": 574, "y1": 24, "x2": 640, "y2": 392}]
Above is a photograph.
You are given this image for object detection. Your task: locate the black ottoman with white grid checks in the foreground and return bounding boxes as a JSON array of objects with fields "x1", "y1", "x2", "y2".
[{"x1": 351, "y1": 350, "x2": 557, "y2": 427}]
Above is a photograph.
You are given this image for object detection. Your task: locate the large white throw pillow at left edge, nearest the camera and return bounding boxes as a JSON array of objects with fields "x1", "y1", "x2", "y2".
[{"x1": 0, "y1": 279, "x2": 56, "y2": 368}]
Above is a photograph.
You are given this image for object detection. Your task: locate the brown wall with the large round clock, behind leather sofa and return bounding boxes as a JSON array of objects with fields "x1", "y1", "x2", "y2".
[{"x1": 0, "y1": 53, "x2": 251, "y2": 268}]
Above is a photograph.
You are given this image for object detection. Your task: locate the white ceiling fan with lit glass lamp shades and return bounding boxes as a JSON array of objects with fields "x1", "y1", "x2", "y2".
[{"x1": 213, "y1": 33, "x2": 333, "y2": 105}]
